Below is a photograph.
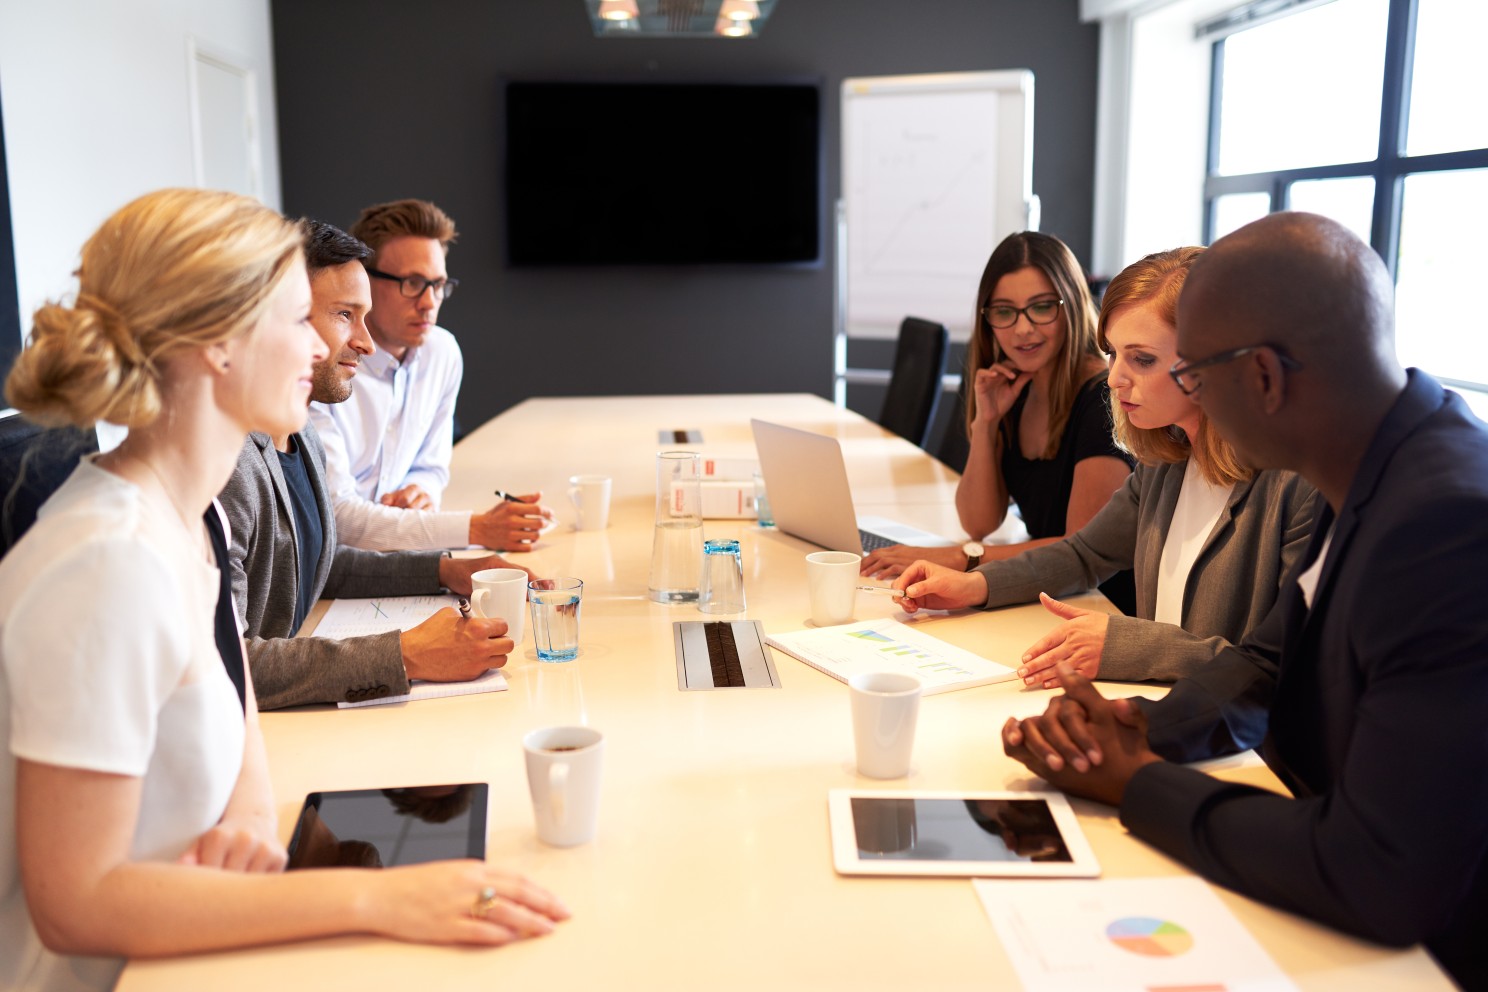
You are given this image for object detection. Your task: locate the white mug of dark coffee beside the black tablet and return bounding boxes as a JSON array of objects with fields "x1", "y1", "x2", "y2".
[{"x1": 522, "y1": 727, "x2": 604, "y2": 848}]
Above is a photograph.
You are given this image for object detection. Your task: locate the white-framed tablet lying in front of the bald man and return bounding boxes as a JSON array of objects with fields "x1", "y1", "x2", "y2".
[{"x1": 827, "y1": 788, "x2": 1101, "y2": 877}]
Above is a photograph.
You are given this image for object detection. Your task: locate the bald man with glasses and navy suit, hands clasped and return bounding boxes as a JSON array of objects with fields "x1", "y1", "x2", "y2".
[{"x1": 970, "y1": 213, "x2": 1488, "y2": 989}]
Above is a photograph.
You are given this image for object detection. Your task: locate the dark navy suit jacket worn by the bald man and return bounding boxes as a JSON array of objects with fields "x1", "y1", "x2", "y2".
[{"x1": 1120, "y1": 369, "x2": 1488, "y2": 988}]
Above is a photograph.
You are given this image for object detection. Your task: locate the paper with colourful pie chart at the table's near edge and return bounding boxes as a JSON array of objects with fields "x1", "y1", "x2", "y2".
[{"x1": 973, "y1": 877, "x2": 1296, "y2": 992}]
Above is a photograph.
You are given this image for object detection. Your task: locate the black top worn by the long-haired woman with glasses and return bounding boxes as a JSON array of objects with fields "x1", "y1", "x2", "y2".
[{"x1": 1003, "y1": 372, "x2": 1137, "y2": 614}]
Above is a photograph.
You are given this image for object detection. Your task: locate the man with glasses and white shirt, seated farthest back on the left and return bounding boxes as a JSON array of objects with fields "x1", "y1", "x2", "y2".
[{"x1": 311, "y1": 199, "x2": 552, "y2": 552}]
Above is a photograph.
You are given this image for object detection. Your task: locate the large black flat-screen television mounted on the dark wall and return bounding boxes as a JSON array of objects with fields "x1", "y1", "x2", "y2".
[{"x1": 506, "y1": 82, "x2": 823, "y2": 266}]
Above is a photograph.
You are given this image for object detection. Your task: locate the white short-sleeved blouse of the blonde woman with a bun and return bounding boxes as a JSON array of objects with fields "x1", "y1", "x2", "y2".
[{"x1": 0, "y1": 460, "x2": 244, "y2": 992}]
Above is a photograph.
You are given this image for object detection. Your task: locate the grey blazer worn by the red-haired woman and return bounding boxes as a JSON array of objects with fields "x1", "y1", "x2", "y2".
[{"x1": 978, "y1": 461, "x2": 1318, "y2": 681}]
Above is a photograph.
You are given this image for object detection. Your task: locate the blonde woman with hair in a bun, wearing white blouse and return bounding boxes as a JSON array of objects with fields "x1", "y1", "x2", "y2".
[{"x1": 0, "y1": 189, "x2": 567, "y2": 992}]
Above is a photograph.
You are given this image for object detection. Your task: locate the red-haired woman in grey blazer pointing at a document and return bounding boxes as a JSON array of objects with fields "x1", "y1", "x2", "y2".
[{"x1": 894, "y1": 248, "x2": 1317, "y2": 689}]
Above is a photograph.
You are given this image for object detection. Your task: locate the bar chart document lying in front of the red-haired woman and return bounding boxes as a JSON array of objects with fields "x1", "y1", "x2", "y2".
[{"x1": 765, "y1": 619, "x2": 1016, "y2": 696}]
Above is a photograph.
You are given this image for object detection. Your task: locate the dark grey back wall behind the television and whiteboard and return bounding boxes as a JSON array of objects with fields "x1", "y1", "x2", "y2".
[{"x1": 272, "y1": 0, "x2": 1098, "y2": 425}]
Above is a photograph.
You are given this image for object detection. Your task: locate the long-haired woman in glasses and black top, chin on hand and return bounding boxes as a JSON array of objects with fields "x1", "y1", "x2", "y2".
[{"x1": 863, "y1": 231, "x2": 1132, "y2": 613}]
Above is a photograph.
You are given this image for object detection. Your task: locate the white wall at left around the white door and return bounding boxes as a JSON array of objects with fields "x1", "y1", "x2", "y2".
[{"x1": 0, "y1": 0, "x2": 280, "y2": 333}]
